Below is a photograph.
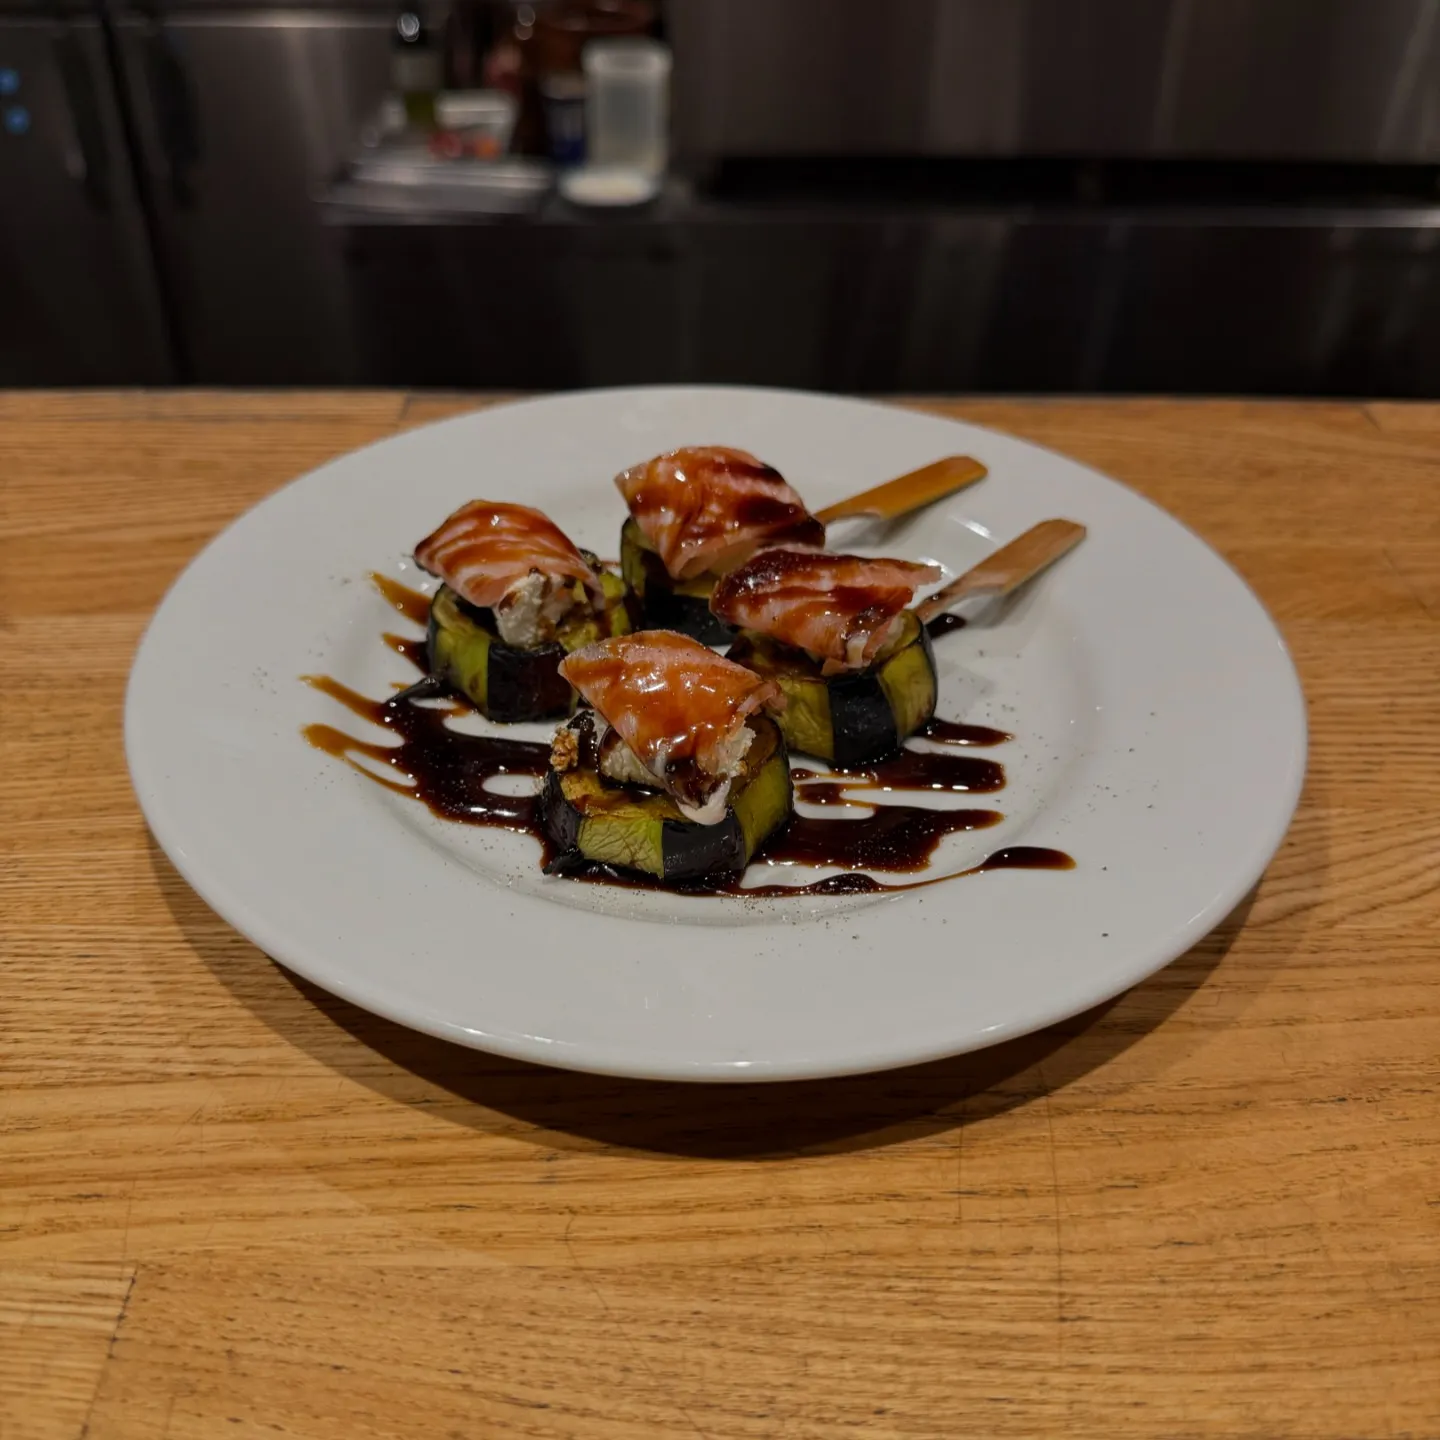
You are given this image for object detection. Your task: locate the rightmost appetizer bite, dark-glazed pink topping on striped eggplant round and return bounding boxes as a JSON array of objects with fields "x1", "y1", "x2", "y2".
[{"x1": 710, "y1": 549, "x2": 942, "y2": 768}]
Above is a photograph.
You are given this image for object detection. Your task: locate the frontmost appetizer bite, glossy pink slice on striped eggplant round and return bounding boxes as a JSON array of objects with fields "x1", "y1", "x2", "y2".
[{"x1": 540, "y1": 631, "x2": 793, "y2": 880}]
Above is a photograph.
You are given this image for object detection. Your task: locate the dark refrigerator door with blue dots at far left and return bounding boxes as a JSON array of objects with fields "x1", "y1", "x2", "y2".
[{"x1": 0, "y1": 0, "x2": 179, "y2": 386}]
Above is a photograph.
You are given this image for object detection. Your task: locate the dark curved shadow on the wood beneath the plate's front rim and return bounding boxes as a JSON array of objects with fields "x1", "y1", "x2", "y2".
[{"x1": 150, "y1": 841, "x2": 1253, "y2": 1159}]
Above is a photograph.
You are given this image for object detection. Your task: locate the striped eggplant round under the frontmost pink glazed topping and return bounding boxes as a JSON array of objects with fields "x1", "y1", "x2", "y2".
[{"x1": 540, "y1": 717, "x2": 795, "y2": 881}]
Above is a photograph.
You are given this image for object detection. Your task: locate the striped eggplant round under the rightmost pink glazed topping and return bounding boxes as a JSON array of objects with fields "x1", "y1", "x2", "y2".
[{"x1": 729, "y1": 611, "x2": 937, "y2": 769}]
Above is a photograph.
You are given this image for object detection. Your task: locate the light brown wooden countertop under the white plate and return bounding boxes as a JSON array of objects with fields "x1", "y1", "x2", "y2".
[{"x1": 0, "y1": 393, "x2": 1440, "y2": 1440}]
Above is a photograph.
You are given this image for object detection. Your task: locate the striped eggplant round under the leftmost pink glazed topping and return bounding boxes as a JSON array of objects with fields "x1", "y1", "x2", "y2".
[{"x1": 425, "y1": 572, "x2": 631, "y2": 724}]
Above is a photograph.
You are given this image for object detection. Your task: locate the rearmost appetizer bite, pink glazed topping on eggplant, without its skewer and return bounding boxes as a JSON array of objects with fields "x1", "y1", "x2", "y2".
[{"x1": 615, "y1": 445, "x2": 825, "y2": 645}]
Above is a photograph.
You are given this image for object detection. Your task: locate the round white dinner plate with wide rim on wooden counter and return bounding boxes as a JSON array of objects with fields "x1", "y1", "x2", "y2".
[{"x1": 125, "y1": 387, "x2": 1305, "y2": 1080}]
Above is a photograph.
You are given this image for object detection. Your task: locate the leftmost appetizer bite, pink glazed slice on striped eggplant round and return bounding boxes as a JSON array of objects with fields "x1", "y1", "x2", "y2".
[{"x1": 415, "y1": 500, "x2": 629, "y2": 723}]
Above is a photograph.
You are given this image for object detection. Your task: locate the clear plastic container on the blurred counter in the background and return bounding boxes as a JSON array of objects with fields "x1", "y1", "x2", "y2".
[{"x1": 580, "y1": 39, "x2": 670, "y2": 176}]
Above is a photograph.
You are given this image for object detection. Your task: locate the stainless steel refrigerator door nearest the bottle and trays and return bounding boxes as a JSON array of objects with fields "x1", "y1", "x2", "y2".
[{"x1": 107, "y1": 0, "x2": 395, "y2": 384}]
